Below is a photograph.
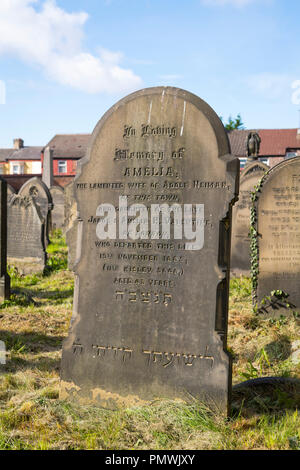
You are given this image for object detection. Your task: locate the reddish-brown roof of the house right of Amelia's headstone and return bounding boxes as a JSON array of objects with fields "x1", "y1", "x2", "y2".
[{"x1": 228, "y1": 129, "x2": 300, "y2": 157}]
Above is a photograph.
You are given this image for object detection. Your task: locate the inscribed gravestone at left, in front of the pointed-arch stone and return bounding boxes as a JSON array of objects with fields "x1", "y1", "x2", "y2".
[{"x1": 7, "y1": 195, "x2": 46, "y2": 274}]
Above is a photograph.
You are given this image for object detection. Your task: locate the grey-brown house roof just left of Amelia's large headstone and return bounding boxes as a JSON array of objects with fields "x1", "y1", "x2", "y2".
[{"x1": 44, "y1": 134, "x2": 91, "y2": 159}]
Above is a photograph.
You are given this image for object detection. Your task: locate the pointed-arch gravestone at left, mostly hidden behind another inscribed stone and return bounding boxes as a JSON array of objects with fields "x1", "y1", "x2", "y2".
[{"x1": 18, "y1": 176, "x2": 53, "y2": 246}]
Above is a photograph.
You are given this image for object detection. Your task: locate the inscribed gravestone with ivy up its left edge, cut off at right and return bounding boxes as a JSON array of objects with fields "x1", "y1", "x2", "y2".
[{"x1": 253, "y1": 157, "x2": 300, "y2": 316}]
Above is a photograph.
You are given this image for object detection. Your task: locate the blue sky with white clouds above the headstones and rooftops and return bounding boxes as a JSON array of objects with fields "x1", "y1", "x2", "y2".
[{"x1": 0, "y1": 0, "x2": 300, "y2": 148}]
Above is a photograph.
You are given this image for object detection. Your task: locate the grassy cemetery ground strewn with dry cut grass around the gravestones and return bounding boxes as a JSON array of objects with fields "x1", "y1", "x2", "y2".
[{"x1": 0, "y1": 232, "x2": 300, "y2": 450}]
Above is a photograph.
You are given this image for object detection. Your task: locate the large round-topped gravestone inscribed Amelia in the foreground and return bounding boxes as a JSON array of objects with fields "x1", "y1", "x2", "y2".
[{"x1": 61, "y1": 87, "x2": 239, "y2": 411}]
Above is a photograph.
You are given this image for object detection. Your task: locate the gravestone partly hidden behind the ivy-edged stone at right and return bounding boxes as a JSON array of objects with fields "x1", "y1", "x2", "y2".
[{"x1": 230, "y1": 161, "x2": 269, "y2": 276}]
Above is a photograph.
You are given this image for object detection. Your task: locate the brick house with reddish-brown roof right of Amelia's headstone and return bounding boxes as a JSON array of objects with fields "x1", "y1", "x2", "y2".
[{"x1": 228, "y1": 129, "x2": 300, "y2": 169}]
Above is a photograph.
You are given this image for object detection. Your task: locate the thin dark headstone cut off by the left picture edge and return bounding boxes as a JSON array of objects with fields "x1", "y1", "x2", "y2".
[{"x1": 0, "y1": 178, "x2": 10, "y2": 302}]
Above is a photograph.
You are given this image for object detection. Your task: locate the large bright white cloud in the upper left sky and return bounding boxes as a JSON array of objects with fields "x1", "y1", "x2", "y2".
[{"x1": 0, "y1": 0, "x2": 141, "y2": 93}]
